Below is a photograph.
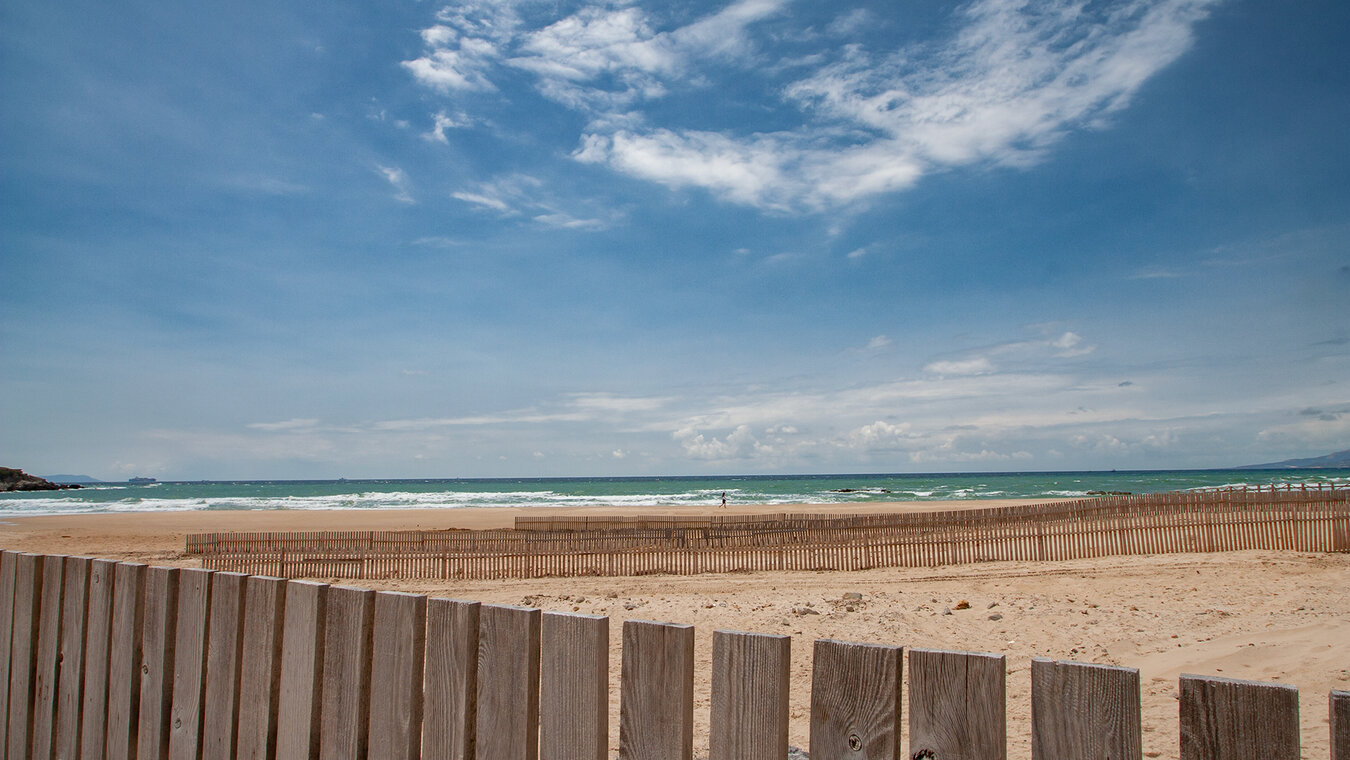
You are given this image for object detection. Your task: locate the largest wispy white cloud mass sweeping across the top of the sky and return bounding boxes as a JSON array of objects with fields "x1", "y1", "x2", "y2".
[{"x1": 404, "y1": 0, "x2": 1218, "y2": 212}]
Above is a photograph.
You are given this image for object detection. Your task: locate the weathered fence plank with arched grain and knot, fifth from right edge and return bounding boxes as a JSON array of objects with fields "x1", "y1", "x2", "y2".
[{"x1": 810, "y1": 639, "x2": 903, "y2": 760}]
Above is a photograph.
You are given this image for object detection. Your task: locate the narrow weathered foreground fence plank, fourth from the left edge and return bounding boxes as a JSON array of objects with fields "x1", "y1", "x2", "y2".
[{"x1": 53, "y1": 556, "x2": 93, "y2": 759}]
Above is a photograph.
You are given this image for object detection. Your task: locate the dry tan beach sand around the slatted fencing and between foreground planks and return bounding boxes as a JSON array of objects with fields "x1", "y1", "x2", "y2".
[{"x1": 0, "y1": 501, "x2": 1350, "y2": 759}]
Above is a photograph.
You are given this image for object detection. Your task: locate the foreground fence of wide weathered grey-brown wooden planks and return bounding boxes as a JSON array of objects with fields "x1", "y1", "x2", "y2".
[{"x1": 0, "y1": 552, "x2": 1350, "y2": 760}]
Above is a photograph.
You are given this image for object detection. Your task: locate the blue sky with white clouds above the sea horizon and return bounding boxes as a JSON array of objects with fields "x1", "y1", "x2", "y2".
[{"x1": 0, "y1": 0, "x2": 1350, "y2": 478}]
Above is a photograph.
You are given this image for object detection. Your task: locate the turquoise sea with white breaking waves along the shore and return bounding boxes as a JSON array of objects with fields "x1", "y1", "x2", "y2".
[{"x1": 0, "y1": 470, "x2": 1350, "y2": 517}]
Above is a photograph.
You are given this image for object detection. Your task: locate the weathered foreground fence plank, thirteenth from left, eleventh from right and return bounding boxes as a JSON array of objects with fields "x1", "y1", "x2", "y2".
[{"x1": 370, "y1": 591, "x2": 427, "y2": 760}]
